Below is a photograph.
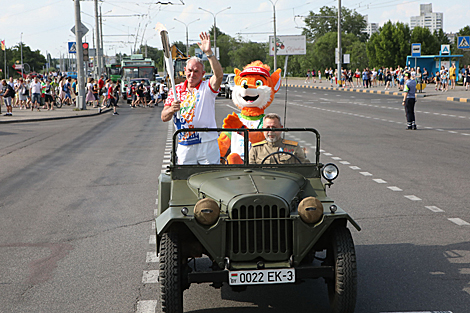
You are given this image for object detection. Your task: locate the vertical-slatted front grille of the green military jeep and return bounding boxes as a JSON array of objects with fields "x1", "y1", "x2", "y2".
[{"x1": 227, "y1": 205, "x2": 292, "y2": 261}]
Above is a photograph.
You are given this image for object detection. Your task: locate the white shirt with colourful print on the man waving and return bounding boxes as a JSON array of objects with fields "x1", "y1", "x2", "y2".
[{"x1": 165, "y1": 80, "x2": 218, "y2": 146}]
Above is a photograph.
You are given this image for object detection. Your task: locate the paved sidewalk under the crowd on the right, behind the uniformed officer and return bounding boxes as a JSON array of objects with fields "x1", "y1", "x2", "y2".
[{"x1": 282, "y1": 77, "x2": 470, "y2": 104}]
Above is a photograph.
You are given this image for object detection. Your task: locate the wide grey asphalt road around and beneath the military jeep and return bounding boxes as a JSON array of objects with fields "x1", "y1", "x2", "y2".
[{"x1": 0, "y1": 88, "x2": 470, "y2": 313}]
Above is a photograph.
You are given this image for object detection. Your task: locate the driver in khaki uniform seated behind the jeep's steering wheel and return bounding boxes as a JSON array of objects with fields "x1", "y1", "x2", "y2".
[{"x1": 250, "y1": 113, "x2": 310, "y2": 164}]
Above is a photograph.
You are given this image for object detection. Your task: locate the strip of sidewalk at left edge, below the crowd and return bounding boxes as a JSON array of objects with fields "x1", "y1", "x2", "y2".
[{"x1": 0, "y1": 104, "x2": 111, "y2": 124}]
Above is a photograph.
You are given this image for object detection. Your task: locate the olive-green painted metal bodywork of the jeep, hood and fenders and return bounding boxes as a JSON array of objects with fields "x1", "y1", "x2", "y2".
[{"x1": 156, "y1": 128, "x2": 360, "y2": 269}]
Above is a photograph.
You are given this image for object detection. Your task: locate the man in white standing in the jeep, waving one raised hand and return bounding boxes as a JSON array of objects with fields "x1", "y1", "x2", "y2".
[{"x1": 161, "y1": 32, "x2": 223, "y2": 164}]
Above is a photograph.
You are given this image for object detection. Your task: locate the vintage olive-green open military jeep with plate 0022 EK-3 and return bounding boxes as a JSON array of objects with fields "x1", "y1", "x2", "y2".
[{"x1": 156, "y1": 128, "x2": 360, "y2": 312}]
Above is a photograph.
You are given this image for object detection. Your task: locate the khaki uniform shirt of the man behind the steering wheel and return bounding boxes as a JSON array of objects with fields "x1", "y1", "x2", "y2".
[{"x1": 250, "y1": 139, "x2": 310, "y2": 164}]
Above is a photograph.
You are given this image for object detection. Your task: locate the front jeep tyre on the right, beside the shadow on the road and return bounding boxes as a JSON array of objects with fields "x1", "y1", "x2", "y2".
[{"x1": 326, "y1": 227, "x2": 357, "y2": 313}]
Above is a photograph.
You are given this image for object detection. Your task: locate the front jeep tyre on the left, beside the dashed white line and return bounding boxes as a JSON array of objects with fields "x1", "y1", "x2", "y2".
[{"x1": 159, "y1": 233, "x2": 183, "y2": 313}]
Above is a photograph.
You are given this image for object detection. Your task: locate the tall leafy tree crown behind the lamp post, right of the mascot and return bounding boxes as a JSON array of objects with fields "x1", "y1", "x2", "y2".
[{"x1": 302, "y1": 6, "x2": 368, "y2": 42}]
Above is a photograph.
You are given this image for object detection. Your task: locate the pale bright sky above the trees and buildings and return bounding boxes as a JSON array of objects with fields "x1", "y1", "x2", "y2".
[{"x1": 0, "y1": 0, "x2": 470, "y2": 58}]
